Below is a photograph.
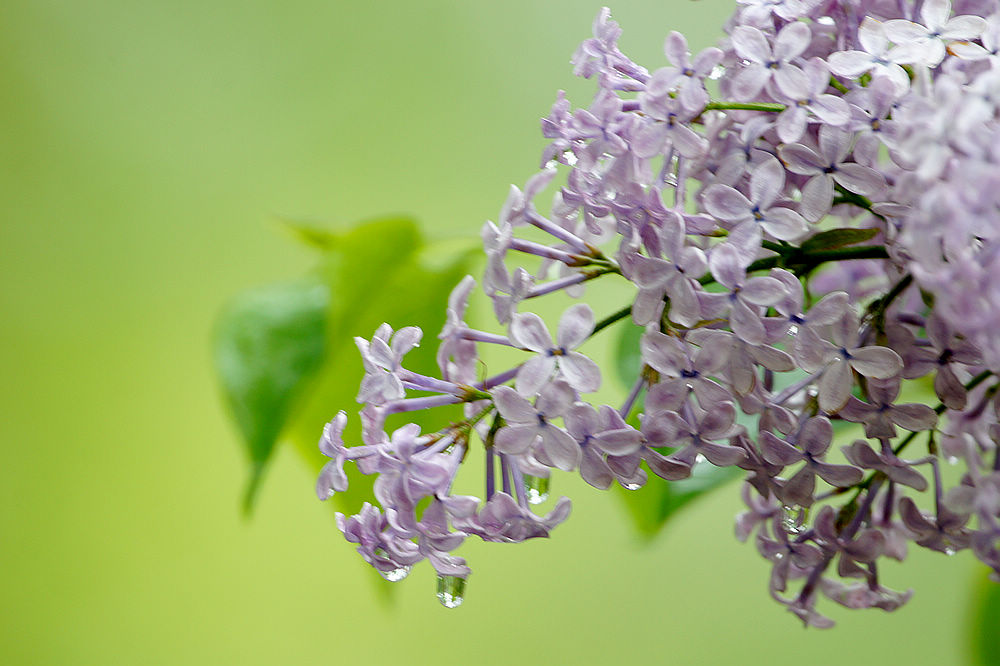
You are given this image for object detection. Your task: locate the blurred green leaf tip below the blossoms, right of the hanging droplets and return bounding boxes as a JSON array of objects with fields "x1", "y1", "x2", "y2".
[{"x1": 617, "y1": 462, "x2": 742, "y2": 539}]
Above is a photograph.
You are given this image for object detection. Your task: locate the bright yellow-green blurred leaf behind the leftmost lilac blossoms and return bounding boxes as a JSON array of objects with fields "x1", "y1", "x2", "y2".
[{"x1": 288, "y1": 218, "x2": 478, "y2": 513}]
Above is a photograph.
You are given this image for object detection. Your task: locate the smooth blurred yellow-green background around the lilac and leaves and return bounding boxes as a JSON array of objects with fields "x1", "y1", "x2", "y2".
[{"x1": 0, "y1": 0, "x2": 979, "y2": 664}]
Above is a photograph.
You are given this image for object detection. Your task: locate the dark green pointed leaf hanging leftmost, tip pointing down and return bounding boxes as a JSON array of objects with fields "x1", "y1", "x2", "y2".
[{"x1": 214, "y1": 281, "x2": 330, "y2": 512}]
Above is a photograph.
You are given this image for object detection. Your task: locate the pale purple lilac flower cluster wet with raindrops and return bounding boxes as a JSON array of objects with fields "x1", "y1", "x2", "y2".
[{"x1": 317, "y1": 0, "x2": 1000, "y2": 627}]
